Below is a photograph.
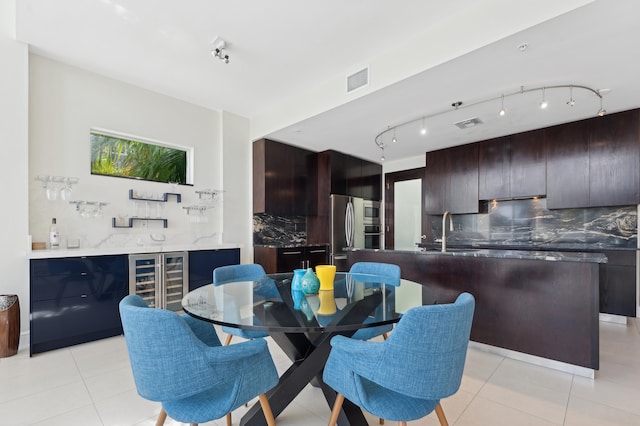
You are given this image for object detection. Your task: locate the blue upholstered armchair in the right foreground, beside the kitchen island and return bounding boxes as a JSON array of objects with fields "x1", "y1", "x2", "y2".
[{"x1": 323, "y1": 293, "x2": 475, "y2": 426}]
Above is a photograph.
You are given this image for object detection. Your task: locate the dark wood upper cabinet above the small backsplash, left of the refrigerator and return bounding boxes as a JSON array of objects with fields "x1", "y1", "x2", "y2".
[{"x1": 253, "y1": 139, "x2": 313, "y2": 216}]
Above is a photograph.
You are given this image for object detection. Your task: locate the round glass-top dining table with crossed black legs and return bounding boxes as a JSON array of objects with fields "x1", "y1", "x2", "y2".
[{"x1": 182, "y1": 272, "x2": 436, "y2": 426}]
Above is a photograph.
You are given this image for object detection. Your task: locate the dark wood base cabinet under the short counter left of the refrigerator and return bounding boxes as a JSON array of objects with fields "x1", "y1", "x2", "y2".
[{"x1": 253, "y1": 245, "x2": 329, "y2": 274}]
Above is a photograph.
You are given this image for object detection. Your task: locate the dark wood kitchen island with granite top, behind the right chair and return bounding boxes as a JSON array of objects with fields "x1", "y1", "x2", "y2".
[{"x1": 349, "y1": 249, "x2": 607, "y2": 377}]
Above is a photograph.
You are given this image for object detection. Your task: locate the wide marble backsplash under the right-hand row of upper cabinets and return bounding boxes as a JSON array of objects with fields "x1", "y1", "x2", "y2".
[{"x1": 431, "y1": 198, "x2": 638, "y2": 248}]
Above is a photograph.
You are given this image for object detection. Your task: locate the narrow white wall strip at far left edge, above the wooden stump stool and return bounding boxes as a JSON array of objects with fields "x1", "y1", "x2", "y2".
[{"x1": 0, "y1": 0, "x2": 29, "y2": 343}]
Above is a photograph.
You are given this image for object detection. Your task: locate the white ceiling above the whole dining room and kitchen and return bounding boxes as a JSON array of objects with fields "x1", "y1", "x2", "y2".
[{"x1": 16, "y1": 0, "x2": 640, "y2": 161}]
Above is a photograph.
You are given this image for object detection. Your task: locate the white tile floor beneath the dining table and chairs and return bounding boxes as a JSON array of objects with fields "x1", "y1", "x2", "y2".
[{"x1": 0, "y1": 319, "x2": 640, "y2": 426}]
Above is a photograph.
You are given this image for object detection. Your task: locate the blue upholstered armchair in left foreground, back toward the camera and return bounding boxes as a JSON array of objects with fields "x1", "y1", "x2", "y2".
[{"x1": 120, "y1": 295, "x2": 278, "y2": 425}]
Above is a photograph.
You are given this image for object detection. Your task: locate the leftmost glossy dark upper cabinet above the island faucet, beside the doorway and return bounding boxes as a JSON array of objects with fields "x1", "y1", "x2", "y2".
[{"x1": 424, "y1": 144, "x2": 479, "y2": 214}]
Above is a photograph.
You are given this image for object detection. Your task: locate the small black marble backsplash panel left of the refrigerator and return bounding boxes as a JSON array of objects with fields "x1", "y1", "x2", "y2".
[{"x1": 253, "y1": 213, "x2": 307, "y2": 246}]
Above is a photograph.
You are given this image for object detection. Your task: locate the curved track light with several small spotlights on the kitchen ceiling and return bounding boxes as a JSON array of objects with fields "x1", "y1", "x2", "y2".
[{"x1": 374, "y1": 84, "x2": 607, "y2": 161}]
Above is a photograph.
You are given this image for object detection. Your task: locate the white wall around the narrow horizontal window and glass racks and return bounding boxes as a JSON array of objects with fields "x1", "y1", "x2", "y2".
[{"x1": 29, "y1": 55, "x2": 231, "y2": 247}]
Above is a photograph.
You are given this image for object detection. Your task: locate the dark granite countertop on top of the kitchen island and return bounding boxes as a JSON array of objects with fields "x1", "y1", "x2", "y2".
[{"x1": 354, "y1": 247, "x2": 607, "y2": 263}]
